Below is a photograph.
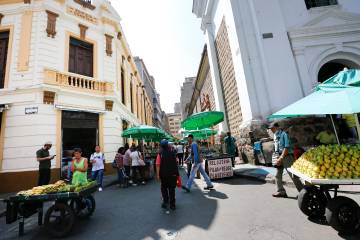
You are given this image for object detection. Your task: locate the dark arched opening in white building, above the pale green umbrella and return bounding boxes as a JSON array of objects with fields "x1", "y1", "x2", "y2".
[{"x1": 318, "y1": 60, "x2": 357, "y2": 83}]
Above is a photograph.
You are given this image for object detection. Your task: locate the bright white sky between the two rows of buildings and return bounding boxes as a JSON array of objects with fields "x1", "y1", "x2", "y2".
[{"x1": 111, "y1": 0, "x2": 204, "y2": 113}]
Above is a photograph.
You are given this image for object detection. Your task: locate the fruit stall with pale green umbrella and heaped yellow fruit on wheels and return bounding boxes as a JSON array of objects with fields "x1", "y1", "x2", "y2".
[{"x1": 269, "y1": 69, "x2": 360, "y2": 234}]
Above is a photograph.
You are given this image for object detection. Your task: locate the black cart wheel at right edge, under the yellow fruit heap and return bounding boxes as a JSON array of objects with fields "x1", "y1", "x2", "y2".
[{"x1": 325, "y1": 196, "x2": 360, "y2": 234}]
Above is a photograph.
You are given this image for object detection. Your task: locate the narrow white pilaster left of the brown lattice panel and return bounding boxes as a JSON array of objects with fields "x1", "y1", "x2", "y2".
[{"x1": 205, "y1": 24, "x2": 229, "y2": 132}]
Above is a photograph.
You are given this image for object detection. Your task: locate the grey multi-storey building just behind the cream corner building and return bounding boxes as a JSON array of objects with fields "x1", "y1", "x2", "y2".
[{"x1": 134, "y1": 57, "x2": 165, "y2": 129}]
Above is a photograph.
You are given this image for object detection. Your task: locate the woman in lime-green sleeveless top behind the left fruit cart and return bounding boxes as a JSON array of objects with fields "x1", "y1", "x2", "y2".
[{"x1": 71, "y1": 148, "x2": 88, "y2": 185}]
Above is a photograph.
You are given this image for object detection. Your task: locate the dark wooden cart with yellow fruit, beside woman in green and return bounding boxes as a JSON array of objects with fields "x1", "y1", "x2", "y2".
[{"x1": 4, "y1": 180, "x2": 97, "y2": 237}]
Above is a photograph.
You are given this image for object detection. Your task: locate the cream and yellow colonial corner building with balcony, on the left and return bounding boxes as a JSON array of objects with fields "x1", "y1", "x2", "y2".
[{"x1": 0, "y1": 0, "x2": 152, "y2": 191}]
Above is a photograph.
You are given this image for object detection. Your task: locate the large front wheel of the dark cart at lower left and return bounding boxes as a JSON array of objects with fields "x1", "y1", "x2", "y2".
[{"x1": 45, "y1": 203, "x2": 75, "y2": 238}]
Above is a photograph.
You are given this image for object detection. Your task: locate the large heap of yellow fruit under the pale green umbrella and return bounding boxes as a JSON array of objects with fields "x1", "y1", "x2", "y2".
[{"x1": 292, "y1": 145, "x2": 360, "y2": 179}]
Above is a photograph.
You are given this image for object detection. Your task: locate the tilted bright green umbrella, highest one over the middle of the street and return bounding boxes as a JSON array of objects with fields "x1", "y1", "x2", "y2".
[{"x1": 181, "y1": 111, "x2": 224, "y2": 130}]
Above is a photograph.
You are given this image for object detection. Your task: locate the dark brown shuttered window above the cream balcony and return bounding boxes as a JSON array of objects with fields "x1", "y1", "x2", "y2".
[{"x1": 69, "y1": 38, "x2": 94, "y2": 77}]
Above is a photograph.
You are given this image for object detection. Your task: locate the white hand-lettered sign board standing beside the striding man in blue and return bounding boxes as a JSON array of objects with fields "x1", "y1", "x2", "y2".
[{"x1": 208, "y1": 158, "x2": 234, "y2": 179}]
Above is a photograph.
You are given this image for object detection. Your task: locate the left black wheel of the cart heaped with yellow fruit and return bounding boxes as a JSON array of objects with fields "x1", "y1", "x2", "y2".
[{"x1": 298, "y1": 186, "x2": 327, "y2": 218}]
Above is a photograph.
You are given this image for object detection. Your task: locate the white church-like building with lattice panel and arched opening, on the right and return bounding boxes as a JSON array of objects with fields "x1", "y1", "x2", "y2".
[{"x1": 193, "y1": 0, "x2": 360, "y2": 160}]
